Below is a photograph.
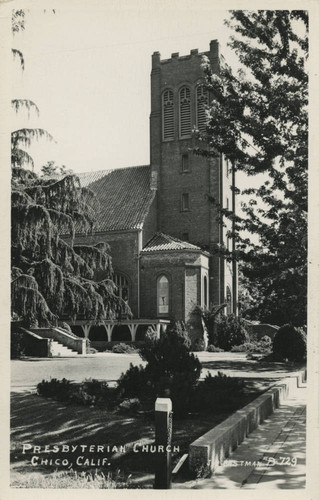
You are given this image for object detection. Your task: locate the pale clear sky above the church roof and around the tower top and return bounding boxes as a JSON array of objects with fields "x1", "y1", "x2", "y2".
[{"x1": 11, "y1": 0, "x2": 241, "y2": 176}]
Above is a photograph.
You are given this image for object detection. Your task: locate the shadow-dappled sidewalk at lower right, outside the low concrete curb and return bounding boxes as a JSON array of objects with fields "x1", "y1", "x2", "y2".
[{"x1": 173, "y1": 384, "x2": 306, "y2": 489}]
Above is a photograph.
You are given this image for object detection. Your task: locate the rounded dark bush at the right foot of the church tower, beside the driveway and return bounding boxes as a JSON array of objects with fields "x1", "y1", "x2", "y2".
[{"x1": 214, "y1": 314, "x2": 249, "y2": 351}]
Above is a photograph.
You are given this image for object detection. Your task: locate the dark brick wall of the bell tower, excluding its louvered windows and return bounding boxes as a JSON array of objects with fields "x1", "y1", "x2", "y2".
[{"x1": 150, "y1": 40, "x2": 228, "y2": 304}]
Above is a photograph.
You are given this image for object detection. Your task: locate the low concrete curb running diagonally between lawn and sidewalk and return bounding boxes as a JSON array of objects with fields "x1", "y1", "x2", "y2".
[{"x1": 189, "y1": 370, "x2": 306, "y2": 472}]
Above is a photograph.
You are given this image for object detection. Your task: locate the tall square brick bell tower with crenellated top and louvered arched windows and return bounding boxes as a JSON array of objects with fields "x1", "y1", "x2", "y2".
[{"x1": 150, "y1": 40, "x2": 237, "y2": 312}]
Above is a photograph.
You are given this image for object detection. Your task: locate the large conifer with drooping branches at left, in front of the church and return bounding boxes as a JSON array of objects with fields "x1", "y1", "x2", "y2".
[{"x1": 11, "y1": 10, "x2": 130, "y2": 326}]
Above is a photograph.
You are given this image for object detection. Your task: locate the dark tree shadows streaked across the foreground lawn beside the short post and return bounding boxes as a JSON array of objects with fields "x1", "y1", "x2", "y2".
[{"x1": 11, "y1": 392, "x2": 205, "y2": 487}]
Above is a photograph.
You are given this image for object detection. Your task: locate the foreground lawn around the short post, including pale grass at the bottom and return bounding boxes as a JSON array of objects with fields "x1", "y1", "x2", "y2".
[{"x1": 11, "y1": 378, "x2": 274, "y2": 489}]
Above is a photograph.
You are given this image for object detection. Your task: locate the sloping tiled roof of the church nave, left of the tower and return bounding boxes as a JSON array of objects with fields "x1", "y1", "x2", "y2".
[{"x1": 78, "y1": 165, "x2": 155, "y2": 232}]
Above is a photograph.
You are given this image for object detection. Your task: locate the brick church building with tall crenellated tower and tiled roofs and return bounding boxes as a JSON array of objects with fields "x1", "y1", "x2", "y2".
[{"x1": 72, "y1": 40, "x2": 237, "y2": 348}]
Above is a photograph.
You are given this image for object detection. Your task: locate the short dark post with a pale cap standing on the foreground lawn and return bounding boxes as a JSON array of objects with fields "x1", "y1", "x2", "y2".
[{"x1": 154, "y1": 398, "x2": 173, "y2": 490}]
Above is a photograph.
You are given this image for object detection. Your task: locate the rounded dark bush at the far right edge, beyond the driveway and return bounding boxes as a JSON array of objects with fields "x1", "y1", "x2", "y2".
[{"x1": 273, "y1": 324, "x2": 307, "y2": 361}]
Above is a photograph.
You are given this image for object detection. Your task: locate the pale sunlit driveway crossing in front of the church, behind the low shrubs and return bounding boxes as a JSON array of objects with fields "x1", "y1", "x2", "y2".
[{"x1": 11, "y1": 352, "x2": 304, "y2": 392}]
